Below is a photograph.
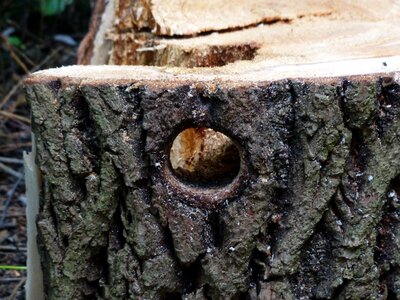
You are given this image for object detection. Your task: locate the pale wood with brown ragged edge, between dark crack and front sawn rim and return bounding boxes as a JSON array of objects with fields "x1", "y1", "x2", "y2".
[{"x1": 111, "y1": 16, "x2": 400, "y2": 67}]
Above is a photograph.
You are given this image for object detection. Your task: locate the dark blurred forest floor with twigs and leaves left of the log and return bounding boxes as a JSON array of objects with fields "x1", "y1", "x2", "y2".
[{"x1": 0, "y1": 0, "x2": 95, "y2": 299}]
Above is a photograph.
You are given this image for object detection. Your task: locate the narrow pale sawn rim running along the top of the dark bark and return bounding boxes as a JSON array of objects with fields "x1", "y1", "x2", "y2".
[{"x1": 26, "y1": 56, "x2": 400, "y2": 86}]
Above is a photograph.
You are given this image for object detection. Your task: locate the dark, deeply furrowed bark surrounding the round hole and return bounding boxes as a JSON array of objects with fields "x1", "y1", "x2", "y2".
[{"x1": 26, "y1": 77, "x2": 400, "y2": 299}]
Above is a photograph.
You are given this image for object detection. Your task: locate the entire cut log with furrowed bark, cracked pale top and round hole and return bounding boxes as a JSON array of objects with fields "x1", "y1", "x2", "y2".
[{"x1": 26, "y1": 0, "x2": 400, "y2": 299}]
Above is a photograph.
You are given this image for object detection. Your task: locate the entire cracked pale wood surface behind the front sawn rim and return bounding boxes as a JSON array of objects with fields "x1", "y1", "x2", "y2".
[{"x1": 80, "y1": 0, "x2": 400, "y2": 67}]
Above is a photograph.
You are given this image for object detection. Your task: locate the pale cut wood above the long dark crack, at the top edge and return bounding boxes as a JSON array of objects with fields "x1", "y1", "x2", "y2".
[{"x1": 121, "y1": 0, "x2": 336, "y2": 36}]
